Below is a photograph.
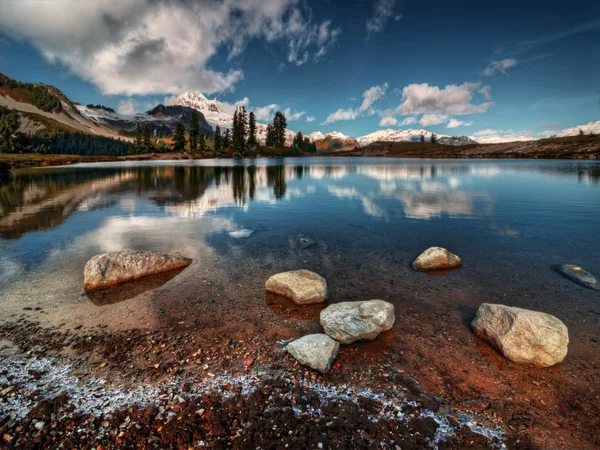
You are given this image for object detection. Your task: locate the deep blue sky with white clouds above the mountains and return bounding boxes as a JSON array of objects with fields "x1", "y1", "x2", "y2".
[{"x1": 0, "y1": 0, "x2": 600, "y2": 140}]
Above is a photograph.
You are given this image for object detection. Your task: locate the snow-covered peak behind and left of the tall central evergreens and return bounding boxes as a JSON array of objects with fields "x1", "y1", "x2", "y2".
[{"x1": 172, "y1": 91, "x2": 296, "y2": 145}]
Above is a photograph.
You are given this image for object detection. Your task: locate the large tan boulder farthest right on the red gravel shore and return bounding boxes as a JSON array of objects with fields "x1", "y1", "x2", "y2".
[{"x1": 471, "y1": 303, "x2": 569, "y2": 367}]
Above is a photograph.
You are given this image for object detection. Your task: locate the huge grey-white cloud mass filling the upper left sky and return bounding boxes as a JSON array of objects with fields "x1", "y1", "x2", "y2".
[{"x1": 0, "y1": 0, "x2": 340, "y2": 95}]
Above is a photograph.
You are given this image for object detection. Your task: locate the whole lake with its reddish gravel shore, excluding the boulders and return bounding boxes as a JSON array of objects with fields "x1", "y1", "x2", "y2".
[{"x1": 0, "y1": 158, "x2": 600, "y2": 448}]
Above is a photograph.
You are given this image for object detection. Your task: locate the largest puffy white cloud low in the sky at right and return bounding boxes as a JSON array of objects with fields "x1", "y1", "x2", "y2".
[{"x1": 397, "y1": 83, "x2": 494, "y2": 116}]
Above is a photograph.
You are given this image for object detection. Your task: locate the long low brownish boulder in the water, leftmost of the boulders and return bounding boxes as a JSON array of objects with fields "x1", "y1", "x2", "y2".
[{"x1": 83, "y1": 250, "x2": 192, "y2": 289}]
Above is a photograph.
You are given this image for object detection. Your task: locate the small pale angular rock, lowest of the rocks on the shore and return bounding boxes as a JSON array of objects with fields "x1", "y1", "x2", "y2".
[{"x1": 286, "y1": 334, "x2": 340, "y2": 373}]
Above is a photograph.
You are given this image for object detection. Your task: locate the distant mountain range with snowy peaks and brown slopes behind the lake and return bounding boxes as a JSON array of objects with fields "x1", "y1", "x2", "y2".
[{"x1": 0, "y1": 74, "x2": 600, "y2": 152}]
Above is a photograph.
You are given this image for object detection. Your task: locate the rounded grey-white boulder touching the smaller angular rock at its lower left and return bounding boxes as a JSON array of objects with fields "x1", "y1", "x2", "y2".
[{"x1": 321, "y1": 300, "x2": 396, "y2": 344}]
